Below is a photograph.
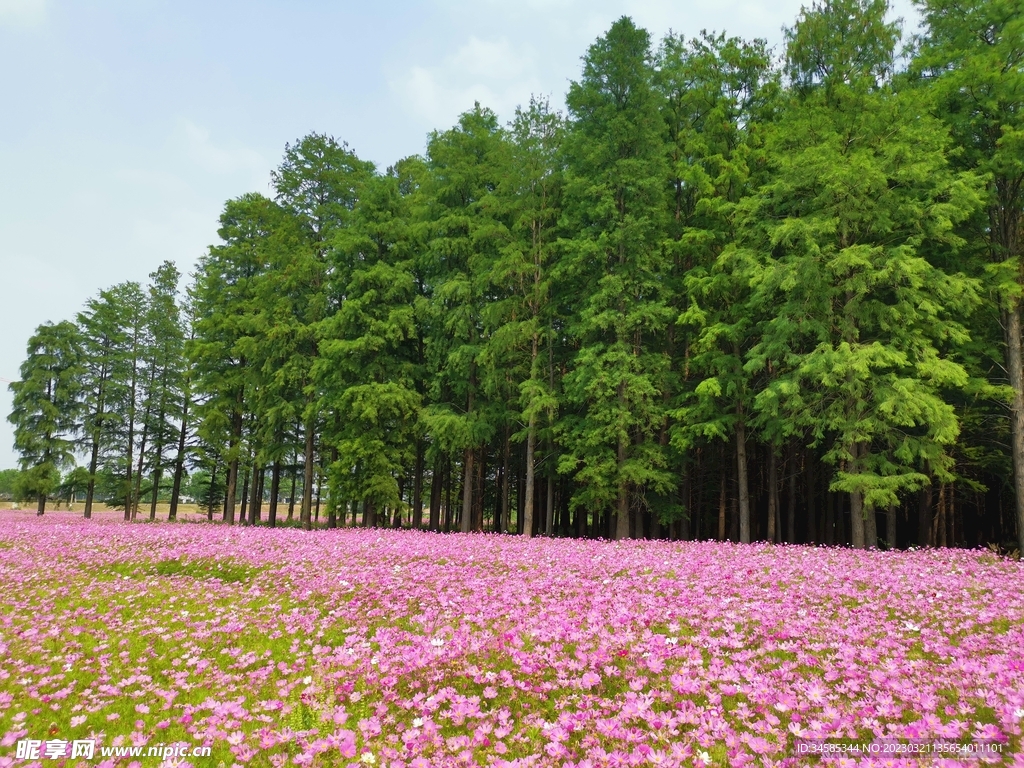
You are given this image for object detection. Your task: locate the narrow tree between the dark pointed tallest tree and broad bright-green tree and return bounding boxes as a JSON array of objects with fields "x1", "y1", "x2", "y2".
[{"x1": 658, "y1": 34, "x2": 778, "y2": 542}]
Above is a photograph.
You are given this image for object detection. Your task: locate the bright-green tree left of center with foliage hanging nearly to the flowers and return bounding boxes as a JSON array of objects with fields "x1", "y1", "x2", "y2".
[{"x1": 314, "y1": 169, "x2": 420, "y2": 524}]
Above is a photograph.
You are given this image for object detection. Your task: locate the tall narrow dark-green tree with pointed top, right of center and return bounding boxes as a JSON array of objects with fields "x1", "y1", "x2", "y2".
[{"x1": 559, "y1": 17, "x2": 675, "y2": 539}]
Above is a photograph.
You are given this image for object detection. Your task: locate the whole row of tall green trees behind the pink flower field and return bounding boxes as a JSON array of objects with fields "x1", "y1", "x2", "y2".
[{"x1": 10, "y1": 0, "x2": 1024, "y2": 548}]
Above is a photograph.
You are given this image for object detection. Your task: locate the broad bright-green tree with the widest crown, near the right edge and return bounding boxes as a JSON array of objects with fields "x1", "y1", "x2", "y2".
[{"x1": 749, "y1": 0, "x2": 977, "y2": 547}]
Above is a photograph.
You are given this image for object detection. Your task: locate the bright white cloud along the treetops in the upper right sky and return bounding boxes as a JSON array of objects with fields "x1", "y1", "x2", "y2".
[{"x1": 390, "y1": 0, "x2": 914, "y2": 135}]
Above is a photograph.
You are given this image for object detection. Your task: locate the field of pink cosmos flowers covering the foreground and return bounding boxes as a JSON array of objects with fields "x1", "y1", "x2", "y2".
[{"x1": 0, "y1": 512, "x2": 1024, "y2": 768}]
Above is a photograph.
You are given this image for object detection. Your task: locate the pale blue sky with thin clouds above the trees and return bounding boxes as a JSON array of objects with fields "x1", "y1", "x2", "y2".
[{"x1": 0, "y1": 0, "x2": 912, "y2": 468}]
